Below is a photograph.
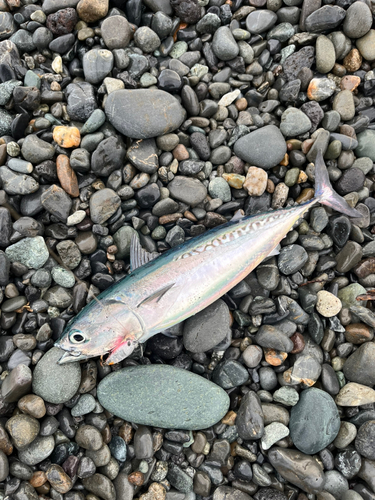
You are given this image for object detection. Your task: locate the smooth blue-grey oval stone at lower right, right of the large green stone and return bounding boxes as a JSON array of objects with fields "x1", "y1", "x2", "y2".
[{"x1": 289, "y1": 388, "x2": 340, "y2": 455}]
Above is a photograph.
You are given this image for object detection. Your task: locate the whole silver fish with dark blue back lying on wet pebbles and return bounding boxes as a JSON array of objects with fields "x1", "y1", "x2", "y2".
[{"x1": 55, "y1": 151, "x2": 361, "y2": 365}]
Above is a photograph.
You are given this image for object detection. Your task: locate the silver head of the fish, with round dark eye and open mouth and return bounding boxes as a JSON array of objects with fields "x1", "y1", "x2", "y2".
[{"x1": 55, "y1": 296, "x2": 137, "y2": 364}]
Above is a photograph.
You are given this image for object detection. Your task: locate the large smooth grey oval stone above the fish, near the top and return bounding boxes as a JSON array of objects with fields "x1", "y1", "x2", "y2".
[{"x1": 105, "y1": 89, "x2": 185, "y2": 139}]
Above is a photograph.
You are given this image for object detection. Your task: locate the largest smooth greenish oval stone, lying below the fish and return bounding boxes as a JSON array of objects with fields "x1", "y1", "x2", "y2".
[{"x1": 97, "y1": 365, "x2": 229, "y2": 430}]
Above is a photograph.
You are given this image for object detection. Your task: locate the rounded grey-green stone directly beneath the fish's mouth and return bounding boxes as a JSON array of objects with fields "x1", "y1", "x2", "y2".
[{"x1": 33, "y1": 347, "x2": 81, "y2": 404}]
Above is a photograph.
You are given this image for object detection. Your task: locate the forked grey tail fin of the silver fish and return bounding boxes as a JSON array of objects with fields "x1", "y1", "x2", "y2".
[{"x1": 315, "y1": 151, "x2": 362, "y2": 217}]
